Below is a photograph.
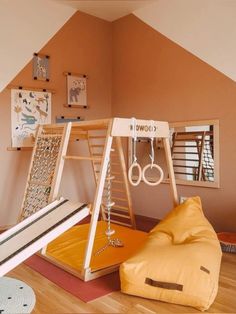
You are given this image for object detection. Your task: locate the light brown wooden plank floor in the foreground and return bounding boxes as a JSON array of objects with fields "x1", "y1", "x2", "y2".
[{"x1": 8, "y1": 254, "x2": 236, "y2": 314}]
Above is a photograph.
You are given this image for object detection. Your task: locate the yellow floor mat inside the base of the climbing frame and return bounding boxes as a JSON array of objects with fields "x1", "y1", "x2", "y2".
[{"x1": 46, "y1": 221, "x2": 147, "y2": 272}]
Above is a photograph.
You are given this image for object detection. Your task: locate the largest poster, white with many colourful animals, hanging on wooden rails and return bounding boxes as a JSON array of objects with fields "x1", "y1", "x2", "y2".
[{"x1": 11, "y1": 89, "x2": 51, "y2": 147}]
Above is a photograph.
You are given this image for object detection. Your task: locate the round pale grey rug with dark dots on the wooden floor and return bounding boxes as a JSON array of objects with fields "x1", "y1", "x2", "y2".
[{"x1": 0, "y1": 277, "x2": 36, "y2": 314}]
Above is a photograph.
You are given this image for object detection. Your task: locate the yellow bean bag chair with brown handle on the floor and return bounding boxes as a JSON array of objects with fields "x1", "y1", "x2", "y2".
[{"x1": 120, "y1": 197, "x2": 222, "y2": 311}]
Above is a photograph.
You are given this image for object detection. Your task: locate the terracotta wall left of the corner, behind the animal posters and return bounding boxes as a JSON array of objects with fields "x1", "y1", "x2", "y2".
[{"x1": 0, "y1": 12, "x2": 112, "y2": 226}]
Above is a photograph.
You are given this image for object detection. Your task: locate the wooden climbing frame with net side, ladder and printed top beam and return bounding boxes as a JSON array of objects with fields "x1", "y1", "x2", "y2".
[{"x1": 11, "y1": 118, "x2": 178, "y2": 281}]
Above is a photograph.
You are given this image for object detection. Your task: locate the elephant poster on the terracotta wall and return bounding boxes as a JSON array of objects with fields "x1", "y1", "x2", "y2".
[{"x1": 67, "y1": 75, "x2": 87, "y2": 108}]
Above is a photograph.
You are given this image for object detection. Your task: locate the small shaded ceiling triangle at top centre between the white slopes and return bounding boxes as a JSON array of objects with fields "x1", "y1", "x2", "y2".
[{"x1": 54, "y1": 0, "x2": 158, "y2": 22}]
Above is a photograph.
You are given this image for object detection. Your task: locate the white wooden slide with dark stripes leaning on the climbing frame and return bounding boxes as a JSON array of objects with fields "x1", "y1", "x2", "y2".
[{"x1": 0, "y1": 198, "x2": 89, "y2": 277}]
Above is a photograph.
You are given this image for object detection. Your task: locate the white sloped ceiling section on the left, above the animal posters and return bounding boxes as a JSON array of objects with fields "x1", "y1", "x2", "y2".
[{"x1": 0, "y1": 0, "x2": 76, "y2": 92}]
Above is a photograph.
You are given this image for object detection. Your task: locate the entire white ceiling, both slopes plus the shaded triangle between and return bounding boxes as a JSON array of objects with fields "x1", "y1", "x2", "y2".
[{"x1": 0, "y1": 0, "x2": 236, "y2": 92}]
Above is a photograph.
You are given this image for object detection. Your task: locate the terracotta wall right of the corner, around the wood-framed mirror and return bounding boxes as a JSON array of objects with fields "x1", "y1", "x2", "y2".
[{"x1": 112, "y1": 15, "x2": 236, "y2": 231}]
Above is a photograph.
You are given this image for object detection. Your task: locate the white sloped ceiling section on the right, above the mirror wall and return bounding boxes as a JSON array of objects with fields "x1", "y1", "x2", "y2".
[{"x1": 134, "y1": 0, "x2": 236, "y2": 81}]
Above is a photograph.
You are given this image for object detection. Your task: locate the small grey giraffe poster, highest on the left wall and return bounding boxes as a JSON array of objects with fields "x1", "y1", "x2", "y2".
[{"x1": 33, "y1": 53, "x2": 49, "y2": 82}]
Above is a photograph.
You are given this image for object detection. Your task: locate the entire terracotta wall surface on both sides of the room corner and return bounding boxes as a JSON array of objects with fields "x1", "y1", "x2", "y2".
[{"x1": 0, "y1": 13, "x2": 236, "y2": 230}]
